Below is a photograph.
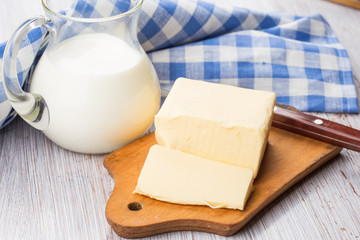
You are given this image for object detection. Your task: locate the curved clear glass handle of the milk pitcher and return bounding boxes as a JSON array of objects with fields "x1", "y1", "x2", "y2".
[{"x1": 2, "y1": 16, "x2": 55, "y2": 130}]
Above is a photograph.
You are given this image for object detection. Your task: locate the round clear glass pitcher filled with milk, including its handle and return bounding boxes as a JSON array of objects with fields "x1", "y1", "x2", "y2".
[{"x1": 3, "y1": 0, "x2": 160, "y2": 153}]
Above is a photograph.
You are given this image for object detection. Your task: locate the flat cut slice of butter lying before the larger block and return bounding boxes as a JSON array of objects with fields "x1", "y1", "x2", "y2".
[{"x1": 134, "y1": 145, "x2": 253, "y2": 210}]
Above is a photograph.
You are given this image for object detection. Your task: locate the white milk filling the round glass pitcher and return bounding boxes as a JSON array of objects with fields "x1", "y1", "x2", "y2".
[{"x1": 30, "y1": 33, "x2": 160, "y2": 153}]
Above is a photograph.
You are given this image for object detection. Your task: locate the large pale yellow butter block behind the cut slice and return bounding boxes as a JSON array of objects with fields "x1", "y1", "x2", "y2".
[{"x1": 155, "y1": 78, "x2": 276, "y2": 178}]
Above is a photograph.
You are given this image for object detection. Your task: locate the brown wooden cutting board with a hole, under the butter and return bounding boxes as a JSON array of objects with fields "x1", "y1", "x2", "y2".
[{"x1": 104, "y1": 127, "x2": 341, "y2": 238}]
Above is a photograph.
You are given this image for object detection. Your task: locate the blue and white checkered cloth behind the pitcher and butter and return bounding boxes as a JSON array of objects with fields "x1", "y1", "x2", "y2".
[{"x1": 0, "y1": 0, "x2": 358, "y2": 127}]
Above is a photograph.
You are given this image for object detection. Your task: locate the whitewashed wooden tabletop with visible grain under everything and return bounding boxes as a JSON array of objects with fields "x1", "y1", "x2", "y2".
[{"x1": 0, "y1": 0, "x2": 360, "y2": 240}]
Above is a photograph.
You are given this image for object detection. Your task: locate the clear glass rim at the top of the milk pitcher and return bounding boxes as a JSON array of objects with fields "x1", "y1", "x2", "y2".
[{"x1": 41, "y1": 0, "x2": 144, "y2": 23}]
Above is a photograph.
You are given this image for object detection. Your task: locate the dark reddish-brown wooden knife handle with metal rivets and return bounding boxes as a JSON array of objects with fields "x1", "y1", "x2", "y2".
[{"x1": 272, "y1": 105, "x2": 360, "y2": 152}]
